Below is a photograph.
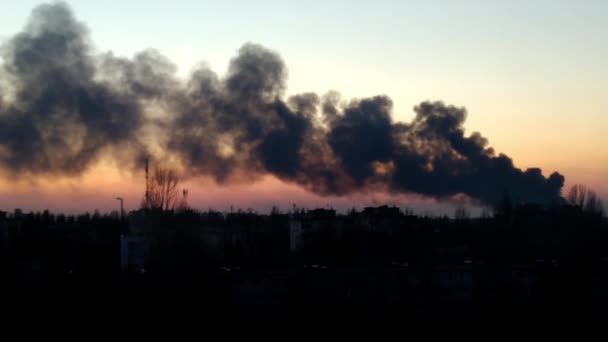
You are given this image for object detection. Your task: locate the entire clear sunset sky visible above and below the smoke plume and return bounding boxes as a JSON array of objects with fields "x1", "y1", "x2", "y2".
[{"x1": 0, "y1": 0, "x2": 608, "y2": 211}]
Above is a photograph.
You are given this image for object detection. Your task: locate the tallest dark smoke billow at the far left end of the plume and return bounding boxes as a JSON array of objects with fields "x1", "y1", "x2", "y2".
[{"x1": 0, "y1": 4, "x2": 143, "y2": 175}]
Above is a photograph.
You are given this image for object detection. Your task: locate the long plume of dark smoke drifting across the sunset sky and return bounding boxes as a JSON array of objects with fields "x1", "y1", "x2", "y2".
[{"x1": 0, "y1": 3, "x2": 564, "y2": 204}]
